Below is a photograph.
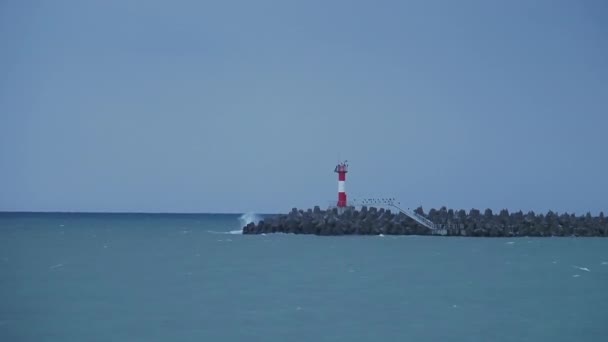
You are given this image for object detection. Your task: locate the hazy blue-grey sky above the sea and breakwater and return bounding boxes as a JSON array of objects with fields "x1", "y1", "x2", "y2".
[{"x1": 0, "y1": 0, "x2": 608, "y2": 214}]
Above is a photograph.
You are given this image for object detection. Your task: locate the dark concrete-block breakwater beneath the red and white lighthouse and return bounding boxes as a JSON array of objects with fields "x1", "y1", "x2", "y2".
[{"x1": 243, "y1": 206, "x2": 608, "y2": 237}]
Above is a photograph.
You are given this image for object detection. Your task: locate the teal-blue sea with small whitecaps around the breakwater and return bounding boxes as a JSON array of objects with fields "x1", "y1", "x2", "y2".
[{"x1": 0, "y1": 213, "x2": 608, "y2": 342}]
